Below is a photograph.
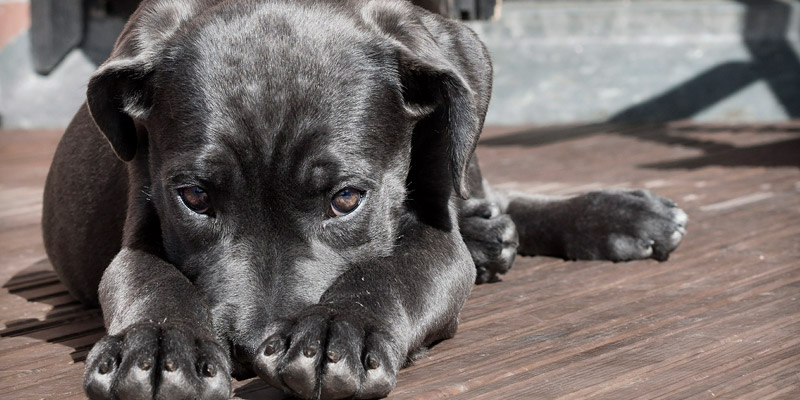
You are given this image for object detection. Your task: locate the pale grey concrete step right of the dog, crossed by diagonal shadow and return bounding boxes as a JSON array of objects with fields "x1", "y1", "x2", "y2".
[{"x1": 469, "y1": 0, "x2": 800, "y2": 124}]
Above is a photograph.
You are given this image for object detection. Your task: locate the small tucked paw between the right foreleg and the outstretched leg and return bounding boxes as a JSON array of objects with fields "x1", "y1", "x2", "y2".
[{"x1": 459, "y1": 199, "x2": 519, "y2": 283}]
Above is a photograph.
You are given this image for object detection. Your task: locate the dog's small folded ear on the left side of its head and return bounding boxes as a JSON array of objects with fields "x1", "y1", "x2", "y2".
[{"x1": 86, "y1": 57, "x2": 153, "y2": 161}]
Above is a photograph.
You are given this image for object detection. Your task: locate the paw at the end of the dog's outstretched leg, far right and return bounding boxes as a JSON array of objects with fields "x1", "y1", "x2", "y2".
[{"x1": 565, "y1": 190, "x2": 689, "y2": 261}]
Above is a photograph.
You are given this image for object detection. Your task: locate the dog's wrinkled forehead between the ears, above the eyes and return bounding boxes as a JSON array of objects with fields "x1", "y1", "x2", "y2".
[{"x1": 150, "y1": 3, "x2": 407, "y2": 179}]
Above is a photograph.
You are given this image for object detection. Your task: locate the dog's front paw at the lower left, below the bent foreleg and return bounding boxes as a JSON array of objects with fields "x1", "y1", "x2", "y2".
[{"x1": 83, "y1": 323, "x2": 231, "y2": 399}]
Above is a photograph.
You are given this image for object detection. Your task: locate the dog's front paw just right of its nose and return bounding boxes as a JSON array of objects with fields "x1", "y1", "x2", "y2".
[{"x1": 254, "y1": 305, "x2": 402, "y2": 399}]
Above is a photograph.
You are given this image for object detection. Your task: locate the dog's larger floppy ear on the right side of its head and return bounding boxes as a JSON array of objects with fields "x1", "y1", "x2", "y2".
[{"x1": 363, "y1": 1, "x2": 492, "y2": 199}]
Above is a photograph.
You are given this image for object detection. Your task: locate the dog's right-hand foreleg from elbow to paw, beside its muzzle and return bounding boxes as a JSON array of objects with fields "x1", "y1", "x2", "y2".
[{"x1": 254, "y1": 225, "x2": 475, "y2": 399}]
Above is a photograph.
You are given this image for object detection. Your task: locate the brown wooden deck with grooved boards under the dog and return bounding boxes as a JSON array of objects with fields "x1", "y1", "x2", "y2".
[{"x1": 0, "y1": 121, "x2": 800, "y2": 399}]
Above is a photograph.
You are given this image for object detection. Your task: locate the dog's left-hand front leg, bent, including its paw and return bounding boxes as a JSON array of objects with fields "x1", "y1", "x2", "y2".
[{"x1": 84, "y1": 248, "x2": 231, "y2": 399}]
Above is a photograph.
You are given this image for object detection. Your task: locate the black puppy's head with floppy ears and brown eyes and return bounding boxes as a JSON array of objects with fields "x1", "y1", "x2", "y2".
[{"x1": 88, "y1": 1, "x2": 489, "y2": 362}]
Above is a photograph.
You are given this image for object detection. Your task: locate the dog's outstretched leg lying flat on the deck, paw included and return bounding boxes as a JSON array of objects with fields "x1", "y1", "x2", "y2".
[{"x1": 500, "y1": 190, "x2": 688, "y2": 261}]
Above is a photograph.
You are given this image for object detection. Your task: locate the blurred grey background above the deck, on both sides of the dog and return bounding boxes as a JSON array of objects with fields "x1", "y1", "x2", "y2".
[{"x1": 0, "y1": 0, "x2": 800, "y2": 129}]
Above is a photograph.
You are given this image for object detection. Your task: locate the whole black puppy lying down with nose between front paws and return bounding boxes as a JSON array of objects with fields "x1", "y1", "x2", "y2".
[{"x1": 43, "y1": 0, "x2": 686, "y2": 399}]
